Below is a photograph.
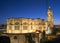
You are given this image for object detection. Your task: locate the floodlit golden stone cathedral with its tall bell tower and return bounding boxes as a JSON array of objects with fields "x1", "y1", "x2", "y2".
[{"x1": 7, "y1": 7, "x2": 54, "y2": 34}]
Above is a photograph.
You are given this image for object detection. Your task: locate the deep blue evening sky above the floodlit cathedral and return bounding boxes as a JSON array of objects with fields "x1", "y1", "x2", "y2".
[{"x1": 0, "y1": 0, "x2": 60, "y2": 24}]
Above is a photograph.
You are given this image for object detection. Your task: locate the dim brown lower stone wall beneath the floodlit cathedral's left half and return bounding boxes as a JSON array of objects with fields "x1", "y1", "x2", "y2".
[{"x1": 9, "y1": 35, "x2": 27, "y2": 43}]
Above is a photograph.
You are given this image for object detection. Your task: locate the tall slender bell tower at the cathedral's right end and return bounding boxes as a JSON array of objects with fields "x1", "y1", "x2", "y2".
[{"x1": 47, "y1": 7, "x2": 54, "y2": 28}]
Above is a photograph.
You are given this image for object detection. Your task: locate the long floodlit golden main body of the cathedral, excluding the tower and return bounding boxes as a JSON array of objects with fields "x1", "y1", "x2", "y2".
[{"x1": 7, "y1": 18, "x2": 46, "y2": 33}]
